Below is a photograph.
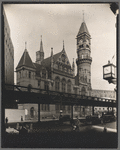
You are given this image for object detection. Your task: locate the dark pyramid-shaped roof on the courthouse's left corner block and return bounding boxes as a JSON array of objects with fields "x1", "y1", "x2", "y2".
[{"x1": 16, "y1": 49, "x2": 35, "y2": 69}]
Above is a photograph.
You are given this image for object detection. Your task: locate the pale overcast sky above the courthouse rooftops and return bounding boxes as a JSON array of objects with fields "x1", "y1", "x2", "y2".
[{"x1": 4, "y1": 4, "x2": 116, "y2": 90}]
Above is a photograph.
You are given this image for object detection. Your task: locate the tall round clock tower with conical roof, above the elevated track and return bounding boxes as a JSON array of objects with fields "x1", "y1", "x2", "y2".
[{"x1": 76, "y1": 21, "x2": 92, "y2": 96}]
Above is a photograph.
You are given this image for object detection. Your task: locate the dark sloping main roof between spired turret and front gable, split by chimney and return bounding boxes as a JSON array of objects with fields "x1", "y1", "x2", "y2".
[{"x1": 41, "y1": 51, "x2": 62, "y2": 68}]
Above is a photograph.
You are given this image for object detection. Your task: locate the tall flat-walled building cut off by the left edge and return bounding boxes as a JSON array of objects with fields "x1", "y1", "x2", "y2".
[{"x1": 3, "y1": 8, "x2": 14, "y2": 85}]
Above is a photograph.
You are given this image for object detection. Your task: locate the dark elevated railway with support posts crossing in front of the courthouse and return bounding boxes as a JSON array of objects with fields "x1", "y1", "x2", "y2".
[{"x1": 3, "y1": 84, "x2": 117, "y2": 121}]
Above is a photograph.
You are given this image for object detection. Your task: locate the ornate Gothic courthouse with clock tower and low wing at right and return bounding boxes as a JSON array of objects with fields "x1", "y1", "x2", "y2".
[{"x1": 16, "y1": 22, "x2": 115, "y2": 120}]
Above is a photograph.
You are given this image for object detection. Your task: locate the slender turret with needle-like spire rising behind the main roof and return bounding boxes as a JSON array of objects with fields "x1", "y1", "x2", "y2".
[{"x1": 36, "y1": 35, "x2": 44, "y2": 64}]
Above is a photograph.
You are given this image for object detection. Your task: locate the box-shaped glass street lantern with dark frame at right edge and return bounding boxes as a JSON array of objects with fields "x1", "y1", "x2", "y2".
[{"x1": 103, "y1": 61, "x2": 116, "y2": 84}]
